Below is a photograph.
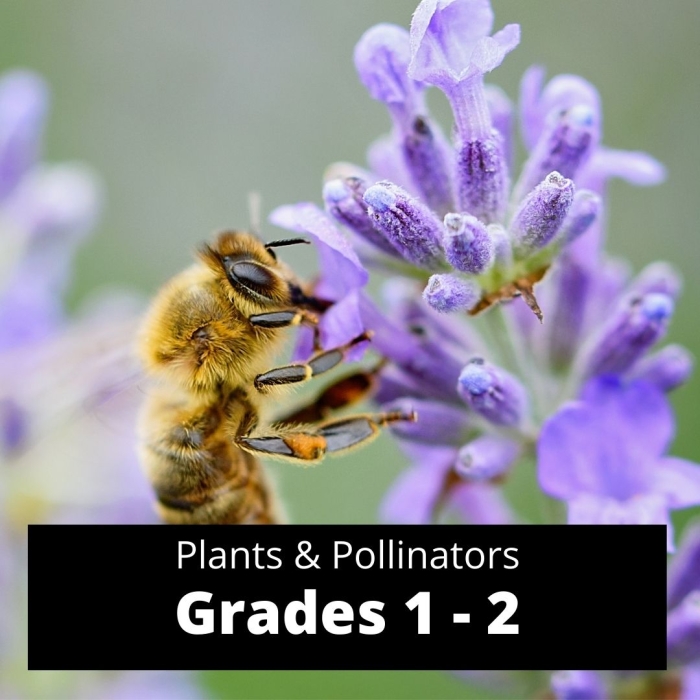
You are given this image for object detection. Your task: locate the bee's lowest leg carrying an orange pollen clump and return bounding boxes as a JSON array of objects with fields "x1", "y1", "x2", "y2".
[{"x1": 236, "y1": 411, "x2": 416, "y2": 464}]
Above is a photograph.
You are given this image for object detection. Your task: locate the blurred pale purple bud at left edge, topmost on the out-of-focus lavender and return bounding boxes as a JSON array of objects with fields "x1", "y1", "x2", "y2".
[{"x1": 0, "y1": 70, "x2": 49, "y2": 199}]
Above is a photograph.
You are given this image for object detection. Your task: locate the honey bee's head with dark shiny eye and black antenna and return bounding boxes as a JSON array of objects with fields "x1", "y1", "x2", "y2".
[{"x1": 199, "y1": 231, "x2": 306, "y2": 307}]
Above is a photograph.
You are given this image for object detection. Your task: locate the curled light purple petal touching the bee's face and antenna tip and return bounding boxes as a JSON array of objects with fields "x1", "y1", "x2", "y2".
[{"x1": 270, "y1": 203, "x2": 369, "y2": 301}]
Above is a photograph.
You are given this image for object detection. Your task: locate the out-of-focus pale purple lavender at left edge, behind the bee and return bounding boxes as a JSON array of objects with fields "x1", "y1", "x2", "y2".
[{"x1": 0, "y1": 71, "x2": 201, "y2": 700}]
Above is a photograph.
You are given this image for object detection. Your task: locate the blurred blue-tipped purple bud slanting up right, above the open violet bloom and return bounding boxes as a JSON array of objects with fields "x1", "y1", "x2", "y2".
[{"x1": 585, "y1": 292, "x2": 674, "y2": 377}]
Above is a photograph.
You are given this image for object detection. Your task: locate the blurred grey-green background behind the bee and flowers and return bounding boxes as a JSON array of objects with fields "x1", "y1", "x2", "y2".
[{"x1": 0, "y1": 0, "x2": 700, "y2": 698}]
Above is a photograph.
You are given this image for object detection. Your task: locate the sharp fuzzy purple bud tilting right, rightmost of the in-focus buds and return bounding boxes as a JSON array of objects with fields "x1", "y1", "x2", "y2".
[{"x1": 510, "y1": 172, "x2": 575, "y2": 254}]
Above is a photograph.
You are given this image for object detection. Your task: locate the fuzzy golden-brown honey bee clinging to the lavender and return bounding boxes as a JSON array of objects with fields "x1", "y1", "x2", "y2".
[{"x1": 139, "y1": 231, "x2": 415, "y2": 524}]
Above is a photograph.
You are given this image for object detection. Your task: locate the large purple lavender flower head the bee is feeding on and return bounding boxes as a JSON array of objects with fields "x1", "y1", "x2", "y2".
[{"x1": 274, "y1": 0, "x2": 700, "y2": 700}]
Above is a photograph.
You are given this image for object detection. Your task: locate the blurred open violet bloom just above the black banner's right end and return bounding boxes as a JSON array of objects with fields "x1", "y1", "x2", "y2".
[{"x1": 537, "y1": 377, "x2": 700, "y2": 551}]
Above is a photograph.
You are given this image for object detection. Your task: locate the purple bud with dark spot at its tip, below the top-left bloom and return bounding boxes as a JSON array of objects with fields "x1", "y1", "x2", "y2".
[{"x1": 402, "y1": 115, "x2": 452, "y2": 213}]
